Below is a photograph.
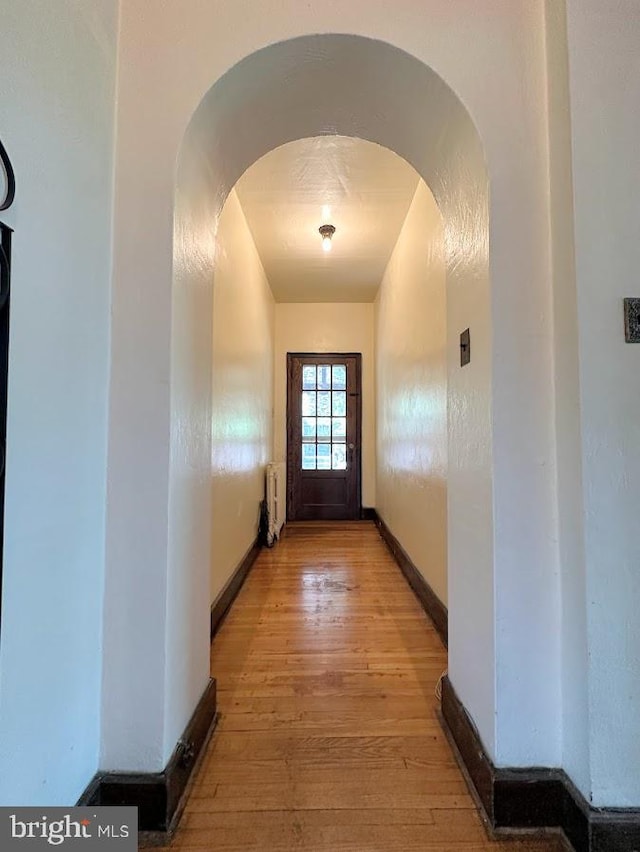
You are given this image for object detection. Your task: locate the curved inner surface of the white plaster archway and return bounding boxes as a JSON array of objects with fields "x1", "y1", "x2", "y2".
[{"x1": 167, "y1": 34, "x2": 495, "y2": 764}]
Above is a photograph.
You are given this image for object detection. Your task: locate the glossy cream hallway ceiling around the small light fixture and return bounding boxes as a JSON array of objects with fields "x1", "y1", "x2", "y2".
[{"x1": 236, "y1": 136, "x2": 419, "y2": 302}]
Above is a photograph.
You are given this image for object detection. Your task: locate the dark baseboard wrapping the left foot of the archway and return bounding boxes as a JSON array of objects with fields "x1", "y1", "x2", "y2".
[{"x1": 78, "y1": 678, "x2": 217, "y2": 832}]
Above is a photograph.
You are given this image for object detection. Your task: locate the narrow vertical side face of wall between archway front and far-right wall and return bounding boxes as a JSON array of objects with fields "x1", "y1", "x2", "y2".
[{"x1": 545, "y1": 0, "x2": 591, "y2": 798}]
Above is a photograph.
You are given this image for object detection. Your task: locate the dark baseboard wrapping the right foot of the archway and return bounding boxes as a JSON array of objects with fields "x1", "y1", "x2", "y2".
[{"x1": 442, "y1": 677, "x2": 640, "y2": 852}]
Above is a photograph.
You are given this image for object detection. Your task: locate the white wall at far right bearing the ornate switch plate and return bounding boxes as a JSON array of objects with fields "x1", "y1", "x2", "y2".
[{"x1": 567, "y1": 0, "x2": 640, "y2": 806}]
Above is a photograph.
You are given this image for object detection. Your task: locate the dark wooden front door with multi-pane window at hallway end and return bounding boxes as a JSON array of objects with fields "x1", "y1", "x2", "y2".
[{"x1": 287, "y1": 353, "x2": 361, "y2": 521}]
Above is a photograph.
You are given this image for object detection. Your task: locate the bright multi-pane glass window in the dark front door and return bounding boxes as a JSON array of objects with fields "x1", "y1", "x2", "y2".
[{"x1": 301, "y1": 364, "x2": 347, "y2": 470}]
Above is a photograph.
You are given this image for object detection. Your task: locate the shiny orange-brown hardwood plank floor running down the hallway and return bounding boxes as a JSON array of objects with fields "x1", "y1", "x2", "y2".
[{"x1": 152, "y1": 522, "x2": 564, "y2": 852}]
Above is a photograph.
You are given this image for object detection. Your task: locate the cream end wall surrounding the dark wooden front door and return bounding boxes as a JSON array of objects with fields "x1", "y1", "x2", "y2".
[{"x1": 274, "y1": 302, "x2": 376, "y2": 506}]
